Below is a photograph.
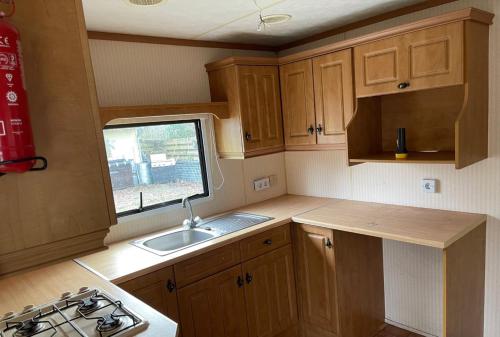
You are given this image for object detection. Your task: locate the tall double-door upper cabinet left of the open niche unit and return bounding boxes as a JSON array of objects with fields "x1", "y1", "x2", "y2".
[{"x1": 280, "y1": 49, "x2": 354, "y2": 150}]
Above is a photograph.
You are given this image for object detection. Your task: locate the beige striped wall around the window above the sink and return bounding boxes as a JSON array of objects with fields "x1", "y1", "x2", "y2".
[{"x1": 90, "y1": 40, "x2": 286, "y2": 243}]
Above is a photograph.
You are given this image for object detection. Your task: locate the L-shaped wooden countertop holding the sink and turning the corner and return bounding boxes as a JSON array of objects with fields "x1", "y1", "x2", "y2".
[{"x1": 77, "y1": 195, "x2": 486, "y2": 284}]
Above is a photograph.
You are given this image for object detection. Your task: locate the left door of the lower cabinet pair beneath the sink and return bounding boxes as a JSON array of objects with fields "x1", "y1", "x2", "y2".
[{"x1": 178, "y1": 265, "x2": 248, "y2": 337}]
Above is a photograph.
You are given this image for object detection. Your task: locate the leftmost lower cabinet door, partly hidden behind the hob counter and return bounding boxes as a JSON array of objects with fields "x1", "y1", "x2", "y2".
[{"x1": 118, "y1": 267, "x2": 179, "y2": 322}]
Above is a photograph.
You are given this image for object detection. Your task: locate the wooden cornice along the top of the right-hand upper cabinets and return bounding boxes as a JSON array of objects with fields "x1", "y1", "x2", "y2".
[{"x1": 279, "y1": 7, "x2": 494, "y2": 65}]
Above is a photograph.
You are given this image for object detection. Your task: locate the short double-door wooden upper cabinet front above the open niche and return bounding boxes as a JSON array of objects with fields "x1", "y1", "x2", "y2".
[{"x1": 354, "y1": 22, "x2": 464, "y2": 97}]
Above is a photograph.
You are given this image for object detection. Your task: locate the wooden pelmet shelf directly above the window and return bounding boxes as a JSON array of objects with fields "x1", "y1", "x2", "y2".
[{"x1": 100, "y1": 102, "x2": 229, "y2": 127}]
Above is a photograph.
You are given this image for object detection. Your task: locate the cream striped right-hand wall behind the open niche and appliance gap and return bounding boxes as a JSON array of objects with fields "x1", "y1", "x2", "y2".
[{"x1": 283, "y1": 0, "x2": 500, "y2": 337}]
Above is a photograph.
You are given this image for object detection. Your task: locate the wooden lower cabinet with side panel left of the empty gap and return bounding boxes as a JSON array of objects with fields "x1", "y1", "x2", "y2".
[{"x1": 293, "y1": 224, "x2": 385, "y2": 337}]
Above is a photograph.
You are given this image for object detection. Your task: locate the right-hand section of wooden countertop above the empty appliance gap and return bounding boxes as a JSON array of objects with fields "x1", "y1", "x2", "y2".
[{"x1": 292, "y1": 199, "x2": 487, "y2": 249}]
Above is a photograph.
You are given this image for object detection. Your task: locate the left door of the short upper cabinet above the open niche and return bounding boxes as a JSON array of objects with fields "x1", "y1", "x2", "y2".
[{"x1": 354, "y1": 36, "x2": 408, "y2": 97}]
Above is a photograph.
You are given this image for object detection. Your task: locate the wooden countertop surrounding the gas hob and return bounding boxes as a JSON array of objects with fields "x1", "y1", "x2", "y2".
[{"x1": 0, "y1": 261, "x2": 177, "y2": 337}]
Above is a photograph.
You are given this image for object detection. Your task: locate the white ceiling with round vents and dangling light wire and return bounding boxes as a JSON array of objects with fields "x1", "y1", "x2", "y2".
[{"x1": 83, "y1": 0, "x2": 423, "y2": 46}]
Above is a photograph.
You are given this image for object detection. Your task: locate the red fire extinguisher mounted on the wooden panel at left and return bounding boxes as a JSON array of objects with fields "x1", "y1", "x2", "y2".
[{"x1": 0, "y1": 0, "x2": 47, "y2": 175}]
